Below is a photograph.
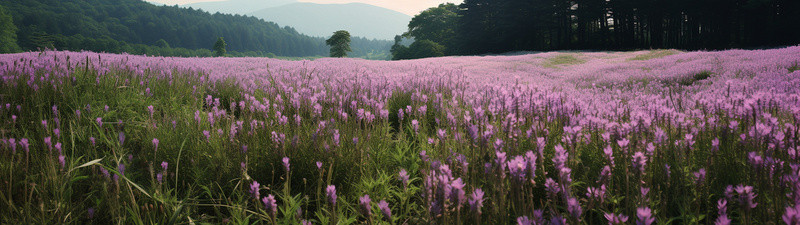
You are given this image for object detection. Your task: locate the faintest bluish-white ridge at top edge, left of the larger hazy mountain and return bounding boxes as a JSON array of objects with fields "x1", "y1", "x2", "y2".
[{"x1": 181, "y1": 0, "x2": 297, "y2": 15}]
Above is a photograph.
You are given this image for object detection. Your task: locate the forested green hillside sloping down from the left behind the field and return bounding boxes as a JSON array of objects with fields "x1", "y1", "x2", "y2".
[{"x1": 0, "y1": 0, "x2": 391, "y2": 56}]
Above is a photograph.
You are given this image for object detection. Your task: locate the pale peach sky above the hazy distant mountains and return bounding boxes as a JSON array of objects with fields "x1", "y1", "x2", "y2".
[{"x1": 147, "y1": 0, "x2": 463, "y2": 16}]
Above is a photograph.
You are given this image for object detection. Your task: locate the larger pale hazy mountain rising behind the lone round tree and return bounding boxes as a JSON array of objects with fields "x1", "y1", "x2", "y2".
[{"x1": 247, "y1": 3, "x2": 411, "y2": 40}]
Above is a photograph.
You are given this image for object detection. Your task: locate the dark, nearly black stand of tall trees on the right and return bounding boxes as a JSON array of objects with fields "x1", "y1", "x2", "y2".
[{"x1": 458, "y1": 0, "x2": 800, "y2": 54}]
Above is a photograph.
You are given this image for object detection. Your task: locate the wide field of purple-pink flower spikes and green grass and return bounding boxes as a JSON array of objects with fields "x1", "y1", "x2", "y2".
[{"x1": 0, "y1": 46, "x2": 800, "y2": 225}]
